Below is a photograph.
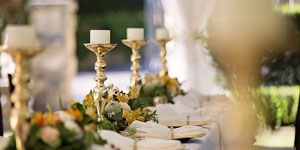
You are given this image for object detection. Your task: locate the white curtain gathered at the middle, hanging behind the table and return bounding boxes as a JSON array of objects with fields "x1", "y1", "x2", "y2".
[{"x1": 162, "y1": 0, "x2": 220, "y2": 95}]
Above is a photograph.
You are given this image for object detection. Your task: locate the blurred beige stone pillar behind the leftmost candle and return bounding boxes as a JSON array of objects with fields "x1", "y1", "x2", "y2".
[{"x1": 30, "y1": 0, "x2": 77, "y2": 111}]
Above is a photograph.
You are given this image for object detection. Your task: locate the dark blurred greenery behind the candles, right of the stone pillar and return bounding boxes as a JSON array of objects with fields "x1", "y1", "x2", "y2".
[{"x1": 77, "y1": 0, "x2": 144, "y2": 71}]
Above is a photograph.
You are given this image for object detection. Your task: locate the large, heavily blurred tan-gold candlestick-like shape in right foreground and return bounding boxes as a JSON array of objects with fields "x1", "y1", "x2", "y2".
[{"x1": 208, "y1": 0, "x2": 287, "y2": 149}]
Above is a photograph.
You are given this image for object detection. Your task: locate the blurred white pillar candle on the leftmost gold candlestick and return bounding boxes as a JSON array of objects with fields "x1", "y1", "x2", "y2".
[{"x1": 3, "y1": 25, "x2": 37, "y2": 49}]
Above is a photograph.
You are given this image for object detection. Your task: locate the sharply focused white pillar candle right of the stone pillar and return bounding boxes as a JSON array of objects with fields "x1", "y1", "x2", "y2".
[{"x1": 90, "y1": 30, "x2": 110, "y2": 44}]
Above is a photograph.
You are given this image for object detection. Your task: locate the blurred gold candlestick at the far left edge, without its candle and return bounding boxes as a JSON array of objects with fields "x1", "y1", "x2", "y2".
[{"x1": 0, "y1": 47, "x2": 41, "y2": 150}]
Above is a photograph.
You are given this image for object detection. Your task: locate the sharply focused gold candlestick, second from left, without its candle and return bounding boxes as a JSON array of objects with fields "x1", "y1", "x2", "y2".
[{"x1": 84, "y1": 43, "x2": 117, "y2": 118}]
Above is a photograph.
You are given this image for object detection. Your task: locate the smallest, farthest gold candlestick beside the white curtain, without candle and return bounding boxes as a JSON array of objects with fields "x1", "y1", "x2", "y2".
[{"x1": 155, "y1": 39, "x2": 170, "y2": 77}]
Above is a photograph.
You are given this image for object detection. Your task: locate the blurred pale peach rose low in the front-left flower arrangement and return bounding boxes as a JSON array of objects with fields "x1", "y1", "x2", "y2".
[{"x1": 41, "y1": 126, "x2": 60, "y2": 146}]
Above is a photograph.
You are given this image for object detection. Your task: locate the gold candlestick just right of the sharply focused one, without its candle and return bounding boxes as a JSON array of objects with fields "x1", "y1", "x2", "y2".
[{"x1": 122, "y1": 39, "x2": 148, "y2": 98}]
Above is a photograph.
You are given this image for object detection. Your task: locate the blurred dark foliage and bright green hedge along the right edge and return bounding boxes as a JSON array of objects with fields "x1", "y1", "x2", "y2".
[{"x1": 260, "y1": 4, "x2": 300, "y2": 128}]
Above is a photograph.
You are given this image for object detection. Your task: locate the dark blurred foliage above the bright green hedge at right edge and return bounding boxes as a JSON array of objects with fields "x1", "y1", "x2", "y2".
[{"x1": 262, "y1": 9, "x2": 300, "y2": 86}]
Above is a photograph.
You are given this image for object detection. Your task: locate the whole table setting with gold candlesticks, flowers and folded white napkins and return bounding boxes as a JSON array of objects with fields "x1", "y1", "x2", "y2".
[{"x1": 0, "y1": 25, "x2": 231, "y2": 150}]
